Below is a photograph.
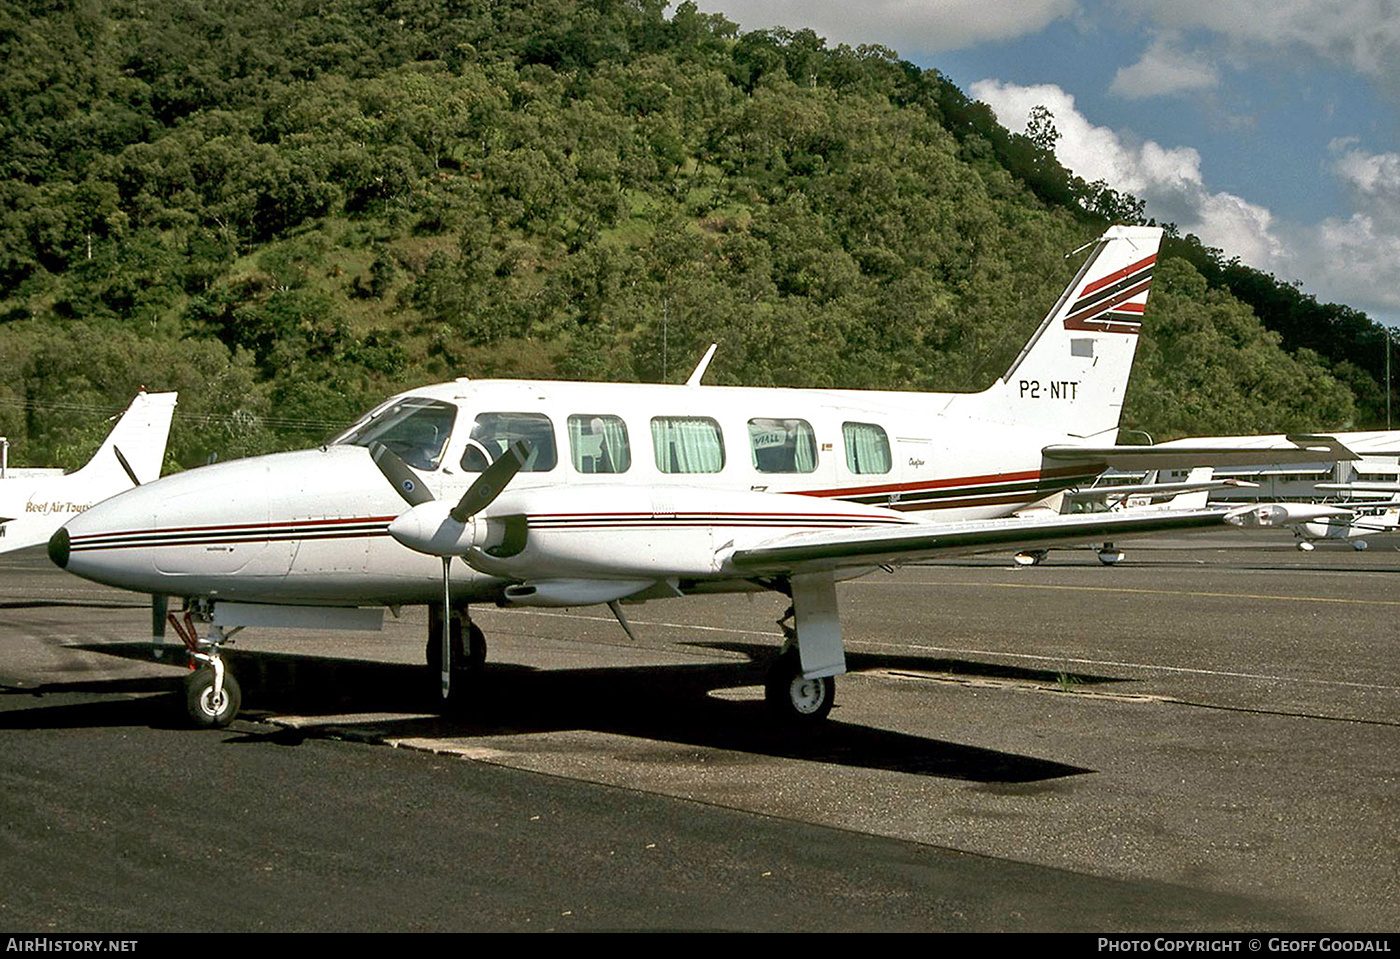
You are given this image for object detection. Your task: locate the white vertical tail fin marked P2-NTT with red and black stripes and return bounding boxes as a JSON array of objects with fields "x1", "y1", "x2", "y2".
[{"x1": 987, "y1": 227, "x2": 1162, "y2": 437}]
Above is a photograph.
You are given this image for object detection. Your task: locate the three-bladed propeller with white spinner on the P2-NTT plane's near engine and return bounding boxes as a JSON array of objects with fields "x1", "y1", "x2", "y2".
[{"x1": 370, "y1": 440, "x2": 532, "y2": 700}]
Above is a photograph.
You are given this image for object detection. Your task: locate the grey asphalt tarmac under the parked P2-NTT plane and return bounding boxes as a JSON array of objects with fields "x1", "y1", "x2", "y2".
[{"x1": 0, "y1": 533, "x2": 1400, "y2": 932}]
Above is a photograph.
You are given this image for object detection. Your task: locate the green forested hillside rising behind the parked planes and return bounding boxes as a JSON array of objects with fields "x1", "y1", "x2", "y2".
[{"x1": 0, "y1": 0, "x2": 1383, "y2": 466}]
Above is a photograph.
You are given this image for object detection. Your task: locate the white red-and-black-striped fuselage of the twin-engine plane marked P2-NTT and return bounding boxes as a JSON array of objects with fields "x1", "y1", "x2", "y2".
[{"x1": 50, "y1": 379, "x2": 1092, "y2": 605}]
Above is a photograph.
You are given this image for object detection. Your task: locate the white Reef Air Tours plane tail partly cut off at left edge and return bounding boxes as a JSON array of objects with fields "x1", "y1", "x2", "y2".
[{"x1": 0, "y1": 391, "x2": 176, "y2": 553}]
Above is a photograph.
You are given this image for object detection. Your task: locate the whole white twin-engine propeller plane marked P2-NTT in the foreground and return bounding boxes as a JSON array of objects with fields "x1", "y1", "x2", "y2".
[{"x1": 49, "y1": 227, "x2": 1282, "y2": 725}]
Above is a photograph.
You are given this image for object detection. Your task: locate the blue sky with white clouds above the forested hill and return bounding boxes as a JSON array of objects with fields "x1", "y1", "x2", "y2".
[{"x1": 697, "y1": 0, "x2": 1400, "y2": 325}]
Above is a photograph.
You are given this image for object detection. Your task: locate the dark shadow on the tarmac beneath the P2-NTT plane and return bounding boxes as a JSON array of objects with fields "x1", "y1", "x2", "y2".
[{"x1": 0, "y1": 643, "x2": 1110, "y2": 784}]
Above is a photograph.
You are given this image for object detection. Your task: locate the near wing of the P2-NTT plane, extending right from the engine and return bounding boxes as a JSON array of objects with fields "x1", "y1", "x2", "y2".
[{"x1": 729, "y1": 507, "x2": 1249, "y2": 573}]
